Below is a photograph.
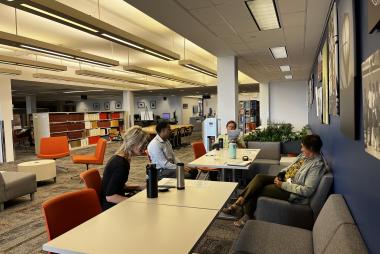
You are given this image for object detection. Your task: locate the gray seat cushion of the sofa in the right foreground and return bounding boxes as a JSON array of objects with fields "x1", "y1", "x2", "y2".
[{"x1": 232, "y1": 220, "x2": 313, "y2": 254}]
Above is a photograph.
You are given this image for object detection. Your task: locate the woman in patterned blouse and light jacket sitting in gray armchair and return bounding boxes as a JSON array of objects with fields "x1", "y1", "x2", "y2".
[{"x1": 223, "y1": 135, "x2": 326, "y2": 227}]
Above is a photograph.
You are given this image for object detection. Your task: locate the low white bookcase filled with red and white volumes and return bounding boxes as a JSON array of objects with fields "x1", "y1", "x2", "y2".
[{"x1": 33, "y1": 111, "x2": 124, "y2": 153}]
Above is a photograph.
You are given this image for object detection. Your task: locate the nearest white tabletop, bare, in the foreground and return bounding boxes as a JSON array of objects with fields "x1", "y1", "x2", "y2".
[{"x1": 42, "y1": 201, "x2": 218, "y2": 254}]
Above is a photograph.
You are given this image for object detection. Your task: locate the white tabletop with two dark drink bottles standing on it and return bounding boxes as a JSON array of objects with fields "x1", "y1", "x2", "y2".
[{"x1": 127, "y1": 178, "x2": 238, "y2": 211}]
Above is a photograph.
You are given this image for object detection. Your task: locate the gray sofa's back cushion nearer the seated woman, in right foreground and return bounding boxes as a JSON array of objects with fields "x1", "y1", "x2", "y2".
[{"x1": 313, "y1": 194, "x2": 354, "y2": 253}]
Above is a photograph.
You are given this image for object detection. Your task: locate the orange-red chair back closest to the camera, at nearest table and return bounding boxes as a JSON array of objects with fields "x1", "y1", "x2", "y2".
[{"x1": 42, "y1": 189, "x2": 102, "y2": 240}]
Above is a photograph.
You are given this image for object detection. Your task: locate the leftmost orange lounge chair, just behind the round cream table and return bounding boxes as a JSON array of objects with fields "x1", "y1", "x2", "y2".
[{"x1": 37, "y1": 136, "x2": 70, "y2": 170}]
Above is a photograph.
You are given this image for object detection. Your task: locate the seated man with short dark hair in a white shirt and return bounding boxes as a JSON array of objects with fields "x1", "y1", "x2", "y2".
[{"x1": 148, "y1": 122, "x2": 198, "y2": 180}]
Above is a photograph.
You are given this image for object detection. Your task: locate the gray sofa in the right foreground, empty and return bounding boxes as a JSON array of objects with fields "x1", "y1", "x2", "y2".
[{"x1": 231, "y1": 194, "x2": 368, "y2": 254}]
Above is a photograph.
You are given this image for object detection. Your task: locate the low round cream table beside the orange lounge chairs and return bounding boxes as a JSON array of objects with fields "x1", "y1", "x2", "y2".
[{"x1": 17, "y1": 160, "x2": 57, "y2": 182}]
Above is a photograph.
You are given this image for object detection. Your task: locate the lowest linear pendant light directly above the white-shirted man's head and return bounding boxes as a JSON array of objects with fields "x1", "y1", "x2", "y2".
[{"x1": 75, "y1": 70, "x2": 176, "y2": 88}]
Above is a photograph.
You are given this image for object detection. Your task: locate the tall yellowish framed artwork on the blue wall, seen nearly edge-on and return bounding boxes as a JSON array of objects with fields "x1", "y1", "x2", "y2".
[{"x1": 322, "y1": 40, "x2": 329, "y2": 124}]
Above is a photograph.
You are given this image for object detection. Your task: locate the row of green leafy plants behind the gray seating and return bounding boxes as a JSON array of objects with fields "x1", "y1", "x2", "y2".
[{"x1": 244, "y1": 123, "x2": 307, "y2": 143}]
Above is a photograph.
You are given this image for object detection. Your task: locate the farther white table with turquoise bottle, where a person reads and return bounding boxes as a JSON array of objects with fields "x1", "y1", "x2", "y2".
[{"x1": 188, "y1": 148, "x2": 260, "y2": 181}]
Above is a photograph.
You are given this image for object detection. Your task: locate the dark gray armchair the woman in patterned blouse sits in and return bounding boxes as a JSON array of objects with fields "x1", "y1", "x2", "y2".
[{"x1": 255, "y1": 172, "x2": 333, "y2": 229}]
